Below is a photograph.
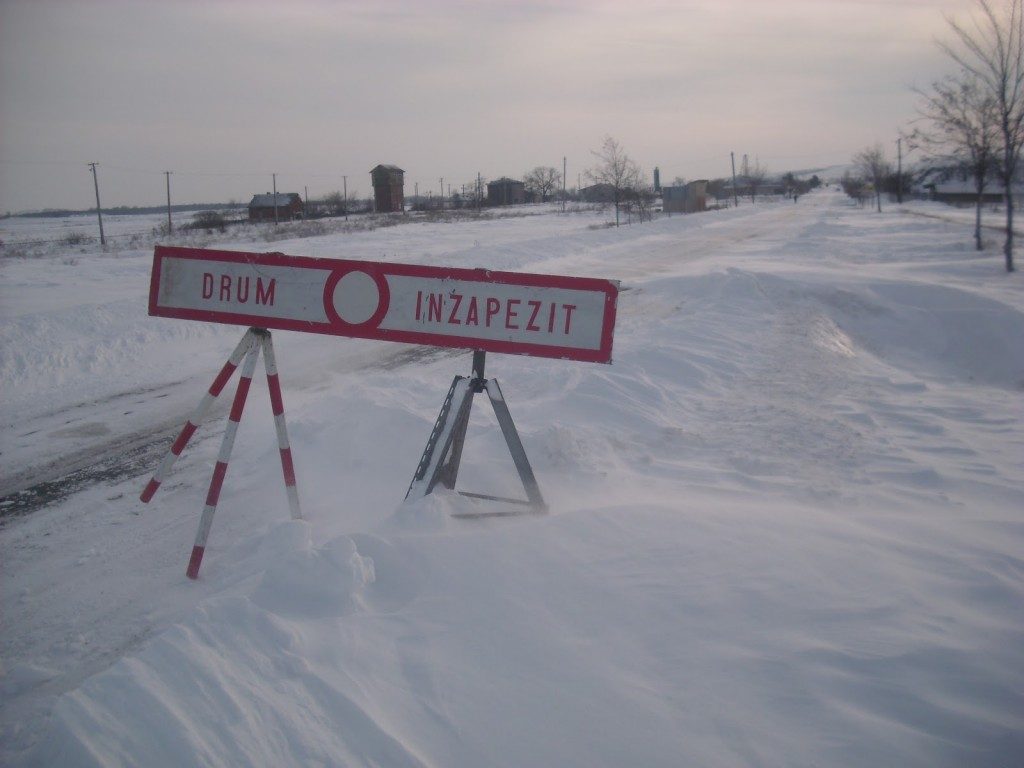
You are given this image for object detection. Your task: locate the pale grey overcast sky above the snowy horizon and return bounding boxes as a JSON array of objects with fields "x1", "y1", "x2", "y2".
[{"x1": 0, "y1": 0, "x2": 972, "y2": 211}]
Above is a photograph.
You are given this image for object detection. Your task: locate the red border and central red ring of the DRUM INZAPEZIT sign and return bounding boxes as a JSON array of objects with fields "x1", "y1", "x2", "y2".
[{"x1": 150, "y1": 246, "x2": 618, "y2": 362}]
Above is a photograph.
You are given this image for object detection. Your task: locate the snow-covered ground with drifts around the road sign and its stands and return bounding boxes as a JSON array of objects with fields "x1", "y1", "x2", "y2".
[{"x1": 0, "y1": 190, "x2": 1024, "y2": 768}]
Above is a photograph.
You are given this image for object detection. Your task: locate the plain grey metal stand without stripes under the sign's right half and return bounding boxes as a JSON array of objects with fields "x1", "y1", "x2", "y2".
[{"x1": 406, "y1": 351, "x2": 548, "y2": 516}]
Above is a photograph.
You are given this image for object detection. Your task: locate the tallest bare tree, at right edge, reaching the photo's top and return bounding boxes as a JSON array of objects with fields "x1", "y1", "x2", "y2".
[{"x1": 940, "y1": 0, "x2": 1024, "y2": 272}]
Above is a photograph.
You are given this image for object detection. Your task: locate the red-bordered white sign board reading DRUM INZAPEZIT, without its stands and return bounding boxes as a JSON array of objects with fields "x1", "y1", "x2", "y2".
[{"x1": 150, "y1": 246, "x2": 618, "y2": 362}]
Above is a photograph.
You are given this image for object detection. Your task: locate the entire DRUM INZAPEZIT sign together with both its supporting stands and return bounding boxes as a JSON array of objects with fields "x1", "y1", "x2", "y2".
[{"x1": 143, "y1": 246, "x2": 618, "y2": 575}]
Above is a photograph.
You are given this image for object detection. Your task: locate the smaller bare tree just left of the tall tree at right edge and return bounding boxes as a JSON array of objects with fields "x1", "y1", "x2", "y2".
[{"x1": 908, "y1": 72, "x2": 999, "y2": 251}]
